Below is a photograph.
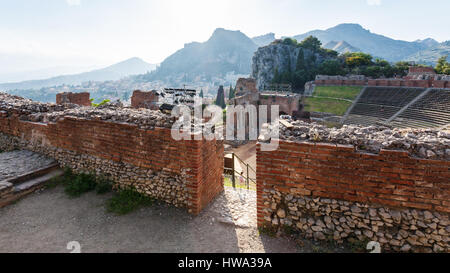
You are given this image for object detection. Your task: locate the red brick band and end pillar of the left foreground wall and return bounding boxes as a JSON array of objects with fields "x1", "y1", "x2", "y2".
[{"x1": 0, "y1": 112, "x2": 223, "y2": 214}]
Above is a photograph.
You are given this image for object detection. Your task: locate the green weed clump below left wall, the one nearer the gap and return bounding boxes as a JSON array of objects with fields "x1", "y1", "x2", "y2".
[{"x1": 106, "y1": 188, "x2": 154, "y2": 215}]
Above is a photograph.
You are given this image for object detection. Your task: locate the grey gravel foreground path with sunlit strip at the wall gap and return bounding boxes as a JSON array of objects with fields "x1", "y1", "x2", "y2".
[{"x1": 0, "y1": 186, "x2": 313, "y2": 253}]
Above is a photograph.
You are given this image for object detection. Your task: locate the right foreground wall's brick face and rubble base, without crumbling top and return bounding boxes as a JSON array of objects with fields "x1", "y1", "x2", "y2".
[{"x1": 257, "y1": 140, "x2": 450, "y2": 252}]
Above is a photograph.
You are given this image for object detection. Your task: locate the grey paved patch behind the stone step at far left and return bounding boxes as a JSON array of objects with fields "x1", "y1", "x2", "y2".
[{"x1": 0, "y1": 151, "x2": 55, "y2": 181}]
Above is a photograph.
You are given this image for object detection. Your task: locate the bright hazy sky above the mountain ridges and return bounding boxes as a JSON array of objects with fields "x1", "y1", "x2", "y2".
[{"x1": 0, "y1": 0, "x2": 450, "y2": 72}]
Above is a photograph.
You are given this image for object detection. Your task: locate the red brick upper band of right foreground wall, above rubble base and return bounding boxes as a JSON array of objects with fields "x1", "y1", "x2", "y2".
[{"x1": 257, "y1": 141, "x2": 450, "y2": 225}]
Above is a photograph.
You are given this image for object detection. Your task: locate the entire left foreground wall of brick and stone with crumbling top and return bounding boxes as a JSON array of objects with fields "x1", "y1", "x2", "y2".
[{"x1": 0, "y1": 92, "x2": 223, "y2": 214}]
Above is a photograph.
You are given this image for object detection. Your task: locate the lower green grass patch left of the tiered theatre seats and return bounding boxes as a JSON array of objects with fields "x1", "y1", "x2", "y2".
[{"x1": 305, "y1": 98, "x2": 352, "y2": 116}]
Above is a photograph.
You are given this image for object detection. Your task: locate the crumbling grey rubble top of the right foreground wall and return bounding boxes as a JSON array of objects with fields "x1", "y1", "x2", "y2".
[{"x1": 262, "y1": 120, "x2": 450, "y2": 161}]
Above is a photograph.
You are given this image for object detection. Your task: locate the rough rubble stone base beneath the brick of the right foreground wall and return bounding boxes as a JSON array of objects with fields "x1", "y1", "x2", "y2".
[{"x1": 263, "y1": 190, "x2": 450, "y2": 252}]
